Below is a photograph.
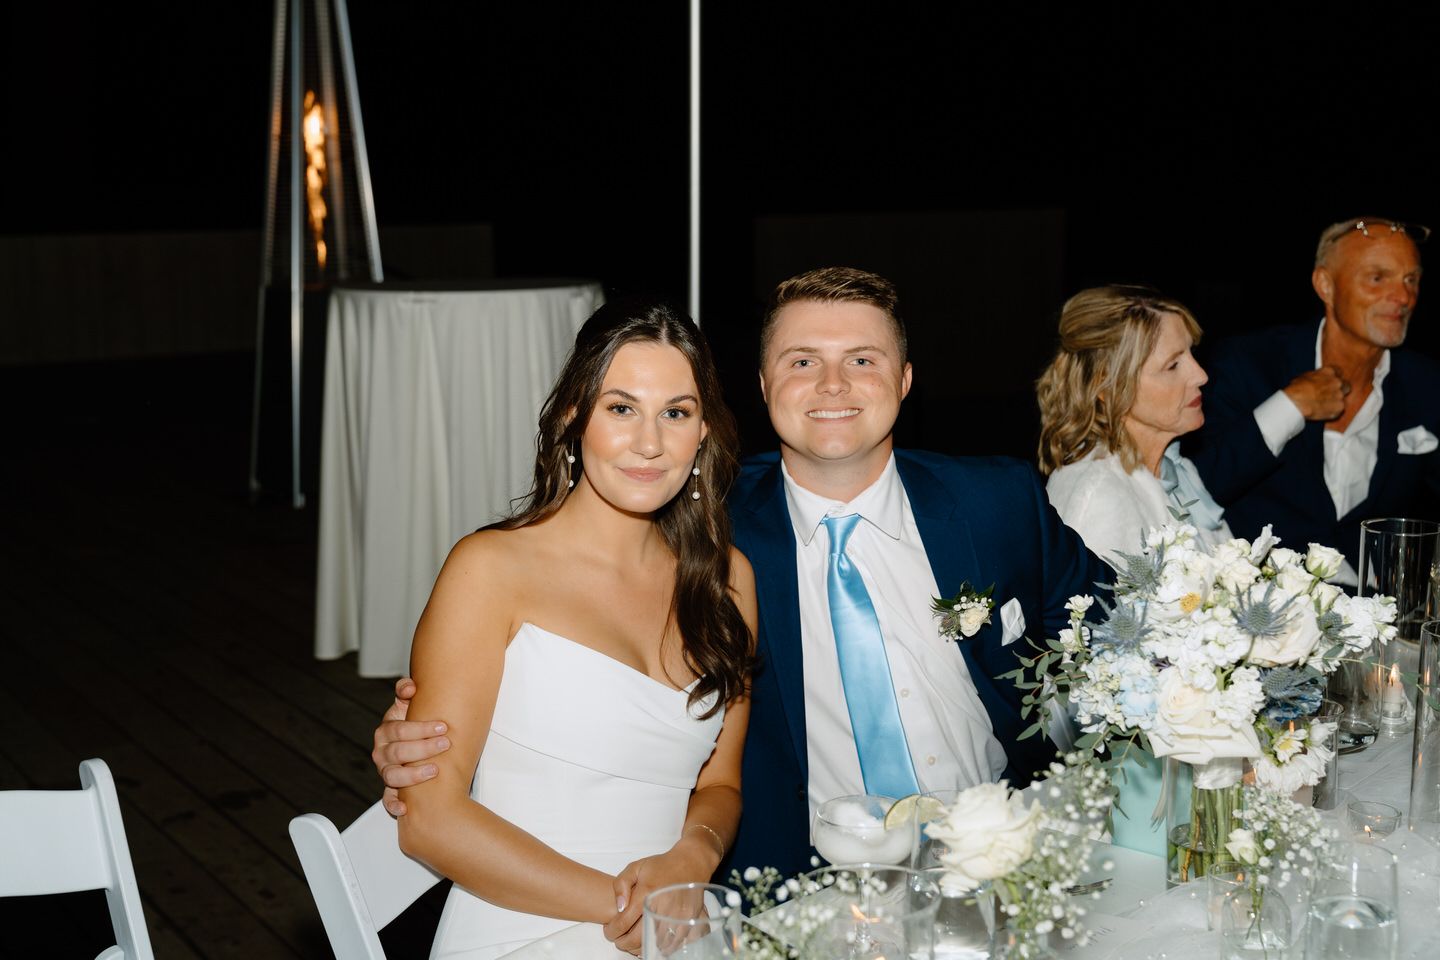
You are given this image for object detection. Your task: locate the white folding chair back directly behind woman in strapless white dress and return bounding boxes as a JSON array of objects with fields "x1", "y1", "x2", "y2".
[{"x1": 289, "y1": 803, "x2": 444, "y2": 960}]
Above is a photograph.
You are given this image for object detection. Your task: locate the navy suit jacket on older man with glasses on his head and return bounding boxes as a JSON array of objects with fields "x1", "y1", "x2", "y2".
[{"x1": 1182, "y1": 324, "x2": 1440, "y2": 566}]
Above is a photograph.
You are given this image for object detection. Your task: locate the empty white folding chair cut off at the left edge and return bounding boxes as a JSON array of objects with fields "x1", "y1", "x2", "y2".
[{"x1": 0, "y1": 760, "x2": 154, "y2": 960}]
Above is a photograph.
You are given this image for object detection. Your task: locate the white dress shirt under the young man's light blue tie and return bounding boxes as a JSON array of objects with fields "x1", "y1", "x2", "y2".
[{"x1": 780, "y1": 456, "x2": 1007, "y2": 816}]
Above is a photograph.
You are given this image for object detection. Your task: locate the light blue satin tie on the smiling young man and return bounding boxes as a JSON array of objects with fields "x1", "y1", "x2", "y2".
[{"x1": 824, "y1": 514, "x2": 920, "y2": 797}]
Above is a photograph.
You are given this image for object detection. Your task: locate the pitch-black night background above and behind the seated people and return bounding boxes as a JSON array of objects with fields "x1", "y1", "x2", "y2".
[{"x1": 11, "y1": 0, "x2": 1440, "y2": 455}]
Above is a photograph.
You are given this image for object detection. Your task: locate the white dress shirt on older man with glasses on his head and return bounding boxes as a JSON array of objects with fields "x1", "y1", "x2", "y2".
[{"x1": 1254, "y1": 321, "x2": 1390, "y2": 584}]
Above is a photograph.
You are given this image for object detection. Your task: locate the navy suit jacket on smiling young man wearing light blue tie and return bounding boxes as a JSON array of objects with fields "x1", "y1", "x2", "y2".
[{"x1": 727, "y1": 450, "x2": 1110, "y2": 875}]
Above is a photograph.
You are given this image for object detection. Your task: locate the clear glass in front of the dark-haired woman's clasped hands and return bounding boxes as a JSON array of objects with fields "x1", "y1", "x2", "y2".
[{"x1": 641, "y1": 884, "x2": 740, "y2": 960}]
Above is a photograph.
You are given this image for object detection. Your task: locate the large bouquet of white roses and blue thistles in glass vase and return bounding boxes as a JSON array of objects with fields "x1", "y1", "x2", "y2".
[{"x1": 1007, "y1": 522, "x2": 1395, "y2": 882}]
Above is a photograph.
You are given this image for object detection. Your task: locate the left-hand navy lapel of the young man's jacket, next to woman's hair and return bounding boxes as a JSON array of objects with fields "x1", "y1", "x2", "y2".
[{"x1": 731, "y1": 458, "x2": 809, "y2": 783}]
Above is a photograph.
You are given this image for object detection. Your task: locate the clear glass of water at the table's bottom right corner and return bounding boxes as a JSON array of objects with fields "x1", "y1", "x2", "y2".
[{"x1": 1305, "y1": 843, "x2": 1400, "y2": 960}]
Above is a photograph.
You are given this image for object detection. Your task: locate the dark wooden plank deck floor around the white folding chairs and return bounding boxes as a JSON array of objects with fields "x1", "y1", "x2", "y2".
[{"x1": 0, "y1": 356, "x2": 438, "y2": 960}]
